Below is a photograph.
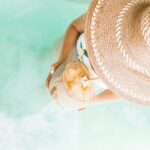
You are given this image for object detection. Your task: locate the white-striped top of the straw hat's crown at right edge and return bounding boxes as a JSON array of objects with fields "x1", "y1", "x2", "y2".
[{"x1": 141, "y1": 7, "x2": 150, "y2": 47}]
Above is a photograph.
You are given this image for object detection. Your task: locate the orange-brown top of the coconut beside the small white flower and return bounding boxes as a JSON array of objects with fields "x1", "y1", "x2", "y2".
[{"x1": 63, "y1": 61, "x2": 90, "y2": 92}]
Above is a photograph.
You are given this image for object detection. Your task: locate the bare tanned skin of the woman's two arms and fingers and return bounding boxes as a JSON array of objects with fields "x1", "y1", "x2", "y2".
[{"x1": 46, "y1": 13, "x2": 121, "y2": 106}]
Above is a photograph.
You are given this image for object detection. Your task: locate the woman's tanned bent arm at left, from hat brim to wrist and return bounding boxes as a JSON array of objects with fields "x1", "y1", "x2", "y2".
[{"x1": 58, "y1": 14, "x2": 86, "y2": 62}]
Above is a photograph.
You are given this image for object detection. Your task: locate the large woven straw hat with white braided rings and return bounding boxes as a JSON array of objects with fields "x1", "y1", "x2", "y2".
[{"x1": 85, "y1": 0, "x2": 150, "y2": 105}]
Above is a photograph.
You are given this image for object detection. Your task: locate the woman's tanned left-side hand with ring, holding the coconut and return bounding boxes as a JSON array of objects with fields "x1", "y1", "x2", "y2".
[{"x1": 46, "y1": 61, "x2": 63, "y2": 89}]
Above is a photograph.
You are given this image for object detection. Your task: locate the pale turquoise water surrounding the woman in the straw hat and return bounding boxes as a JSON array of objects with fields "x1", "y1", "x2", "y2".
[{"x1": 0, "y1": 0, "x2": 150, "y2": 150}]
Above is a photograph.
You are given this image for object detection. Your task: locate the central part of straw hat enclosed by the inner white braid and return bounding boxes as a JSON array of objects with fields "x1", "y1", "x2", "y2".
[{"x1": 116, "y1": 1, "x2": 150, "y2": 76}]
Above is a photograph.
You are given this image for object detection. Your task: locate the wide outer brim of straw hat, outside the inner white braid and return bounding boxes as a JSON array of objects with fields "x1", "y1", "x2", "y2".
[{"x1": 85, "y1": 0, "x2": 150, "y2": 105}]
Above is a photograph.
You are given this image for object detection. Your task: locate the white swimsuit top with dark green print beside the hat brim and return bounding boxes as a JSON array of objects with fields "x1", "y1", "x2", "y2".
[{"x1": 76, "y1": 33, "x2": 109, "y2": 89}]
